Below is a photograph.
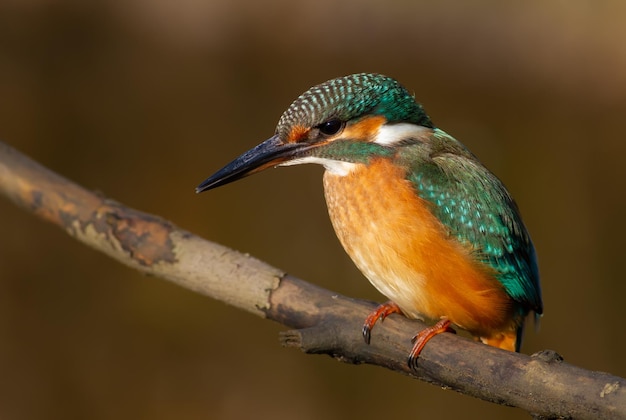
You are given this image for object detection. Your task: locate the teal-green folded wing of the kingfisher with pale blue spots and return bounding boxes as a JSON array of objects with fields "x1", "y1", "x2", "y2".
[{"x1": 400, "y1": 130, "x2": 543, "y2": 314}]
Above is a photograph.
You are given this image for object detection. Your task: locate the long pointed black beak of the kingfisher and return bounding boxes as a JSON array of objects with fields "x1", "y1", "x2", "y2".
[{"x1": 196, "y1": 135, "x2": 309, "y2": 193}]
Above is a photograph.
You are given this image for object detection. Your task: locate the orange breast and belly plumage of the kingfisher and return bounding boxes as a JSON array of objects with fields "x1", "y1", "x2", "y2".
[{"x1": 324, "y1": 159, "x2": 516, "y2": 347}]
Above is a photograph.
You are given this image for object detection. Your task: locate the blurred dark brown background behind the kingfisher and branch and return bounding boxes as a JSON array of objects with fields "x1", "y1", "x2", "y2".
[{"x1": 0, "y1": 0, "x2": 626, "y2": 419}]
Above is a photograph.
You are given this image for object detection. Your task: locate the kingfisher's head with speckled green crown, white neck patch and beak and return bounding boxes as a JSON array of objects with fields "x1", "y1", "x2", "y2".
[{"x1": 196, "y1": 73, "x2": 433, "y2": 192}]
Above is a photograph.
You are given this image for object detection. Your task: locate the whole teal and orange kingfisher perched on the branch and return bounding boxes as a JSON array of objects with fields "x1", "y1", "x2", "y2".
[{"x1": 196, "y1": 73, "x2": 543, "y2": 368}]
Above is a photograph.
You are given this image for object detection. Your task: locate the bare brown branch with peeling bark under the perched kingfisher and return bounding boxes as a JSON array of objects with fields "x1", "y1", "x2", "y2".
[{"x1": 0, "y1": 143, "x2": 626, "y2": 418}]
